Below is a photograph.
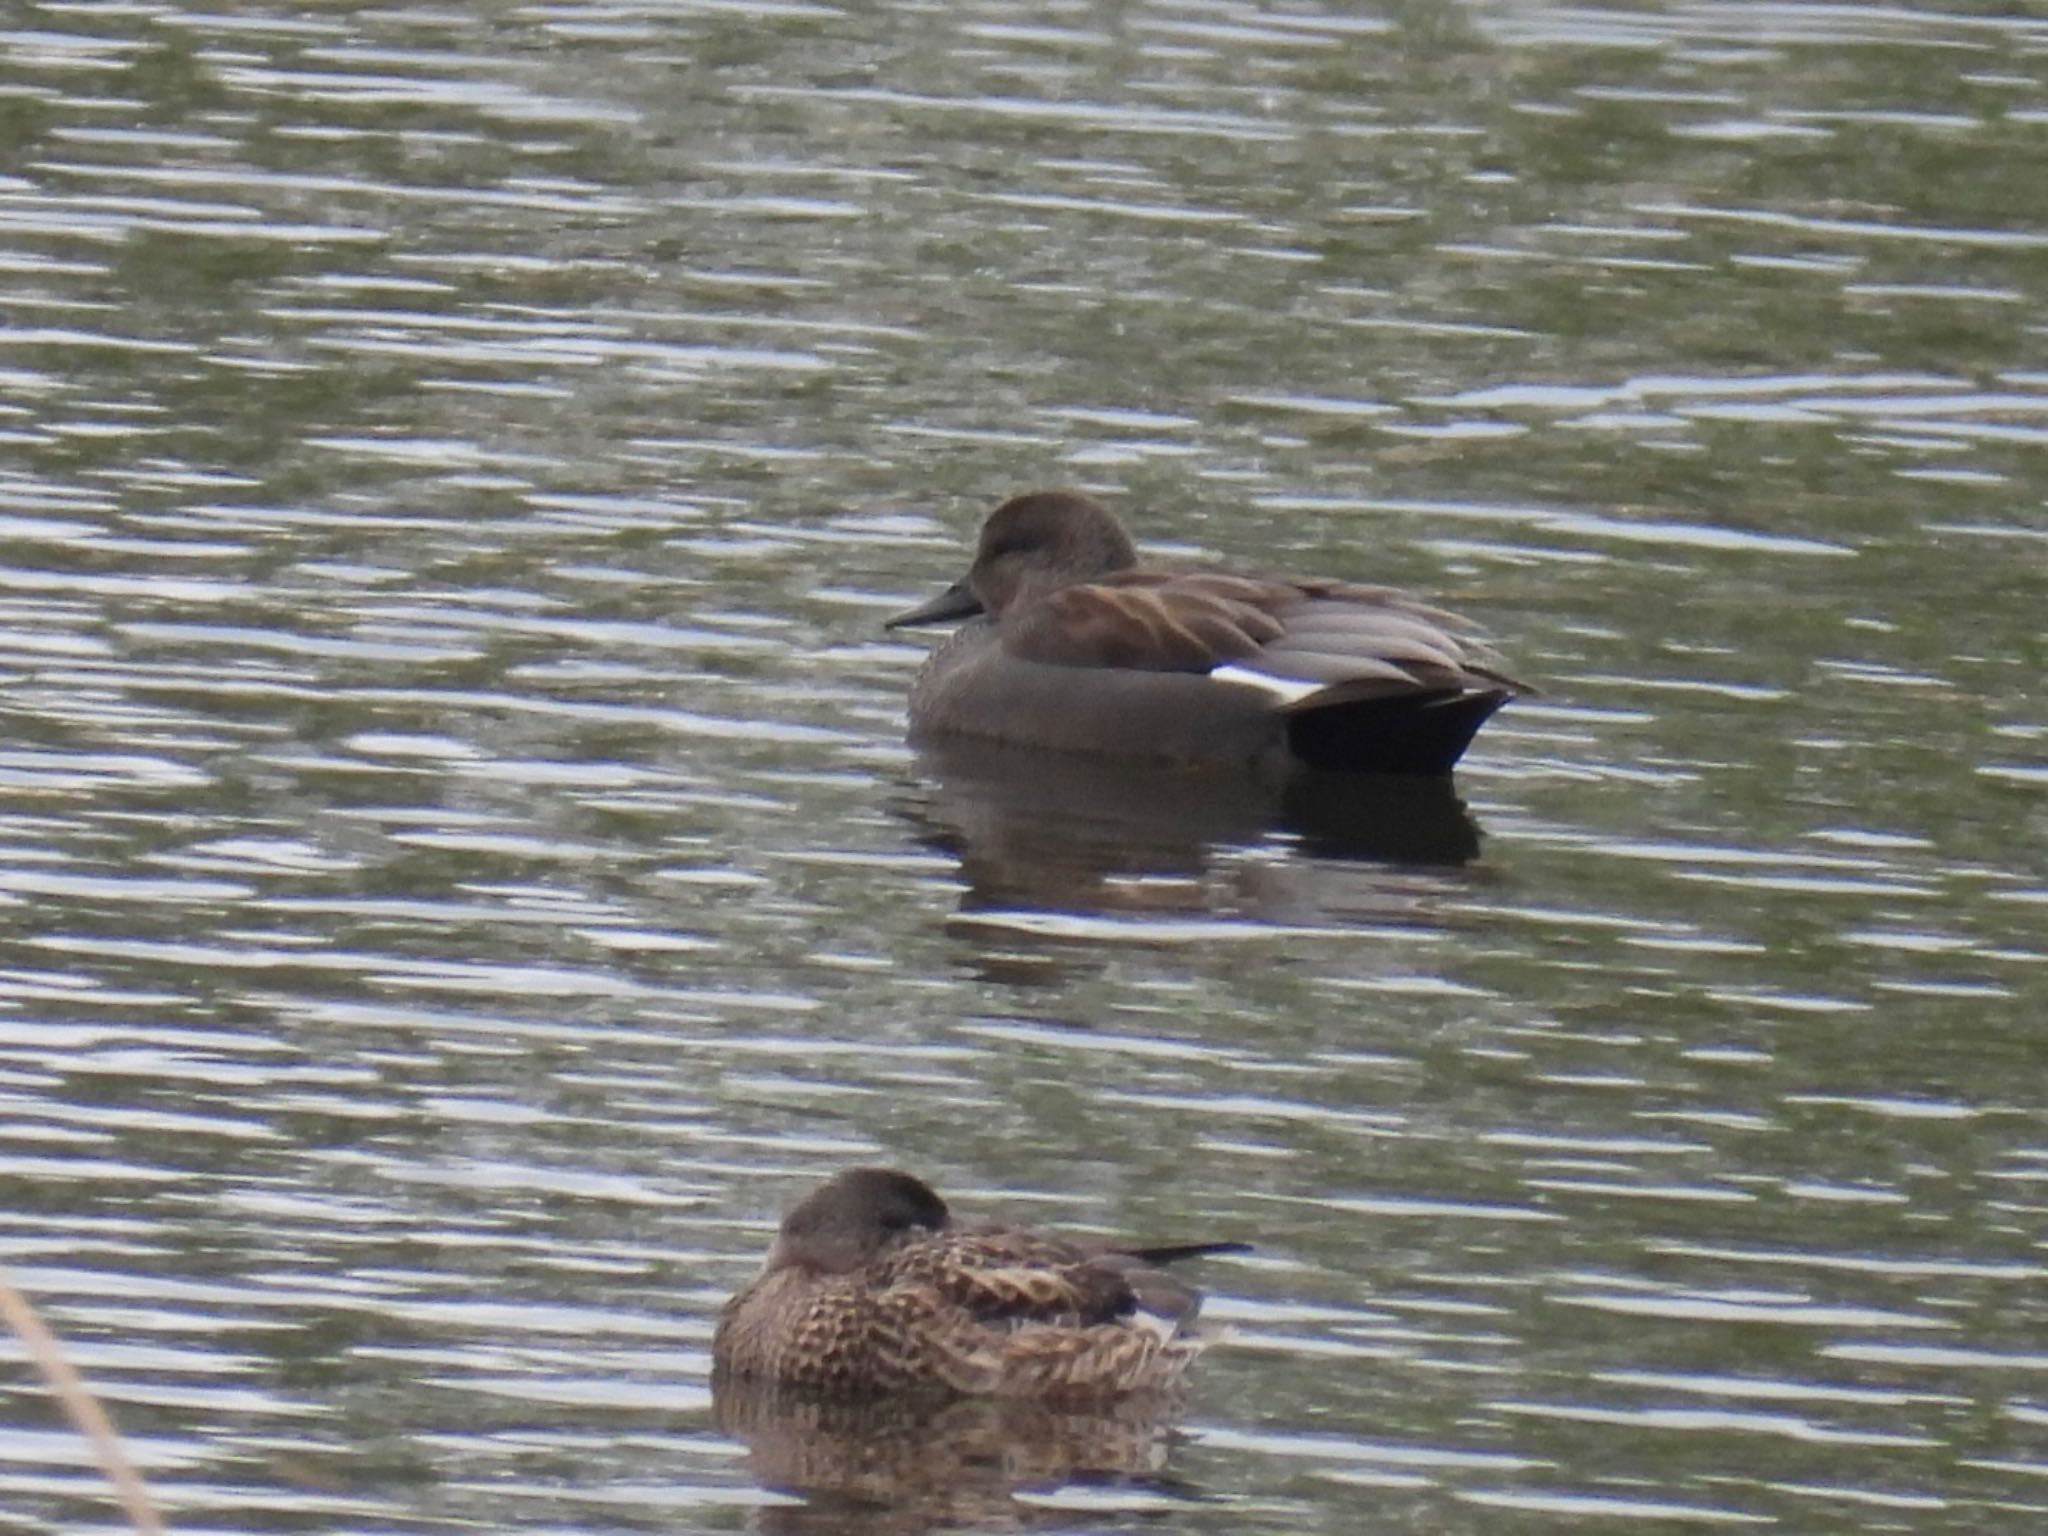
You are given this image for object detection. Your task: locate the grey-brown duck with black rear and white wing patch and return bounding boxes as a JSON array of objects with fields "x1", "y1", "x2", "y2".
[{"x1": 887, "y1": 492, "x2": 1528, "y2": 774}]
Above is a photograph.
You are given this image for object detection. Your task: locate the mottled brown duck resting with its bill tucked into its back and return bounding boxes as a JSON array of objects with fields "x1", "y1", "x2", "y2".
[{"x1": 711, "y1": 1167, "x2": 1245, "y2": 1401}]
